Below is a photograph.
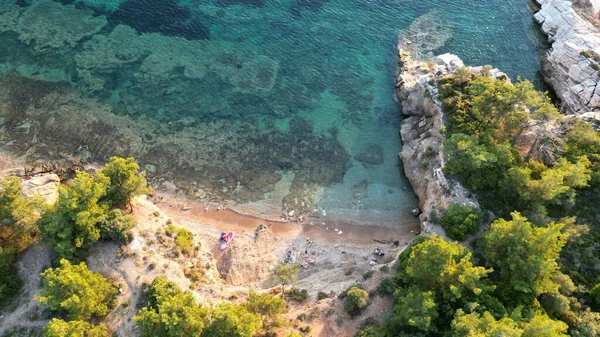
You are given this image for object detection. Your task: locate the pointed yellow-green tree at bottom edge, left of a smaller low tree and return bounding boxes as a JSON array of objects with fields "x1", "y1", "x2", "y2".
[{"x1": 133, "y1": 276, "x2": 208, "y2": 337}]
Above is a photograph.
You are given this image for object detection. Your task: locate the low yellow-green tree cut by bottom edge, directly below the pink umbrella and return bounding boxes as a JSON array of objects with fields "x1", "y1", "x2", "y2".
[{"x1": 202, "y1": 303, "x2": 262, "y2": 337}]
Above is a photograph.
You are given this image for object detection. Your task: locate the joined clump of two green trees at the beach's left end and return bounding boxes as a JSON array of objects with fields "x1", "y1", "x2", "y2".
[{"x1": 39, "y1": 157, "x2": 147, "y2": 261}]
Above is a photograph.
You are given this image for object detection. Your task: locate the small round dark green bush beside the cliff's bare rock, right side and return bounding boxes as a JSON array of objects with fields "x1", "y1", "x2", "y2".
[{"x1": 440, "y1": 204, "x2": 479, "y2": 241}]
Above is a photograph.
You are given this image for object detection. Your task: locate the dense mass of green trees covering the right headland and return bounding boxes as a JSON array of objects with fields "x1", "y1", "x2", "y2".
[{"x1": 357, "y1": 68, "x2": 600, "y2": 337}]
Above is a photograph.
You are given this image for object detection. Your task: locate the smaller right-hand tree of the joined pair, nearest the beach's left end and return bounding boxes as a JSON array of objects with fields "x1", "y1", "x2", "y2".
[{"x1": 98, "y1": 157, "x2": 149, "y2": 209}]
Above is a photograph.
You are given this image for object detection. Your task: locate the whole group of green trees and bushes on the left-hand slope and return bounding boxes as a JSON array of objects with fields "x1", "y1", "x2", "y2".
[{"x1": 0, "y1": 157, "x2": 147, "y2": 337}]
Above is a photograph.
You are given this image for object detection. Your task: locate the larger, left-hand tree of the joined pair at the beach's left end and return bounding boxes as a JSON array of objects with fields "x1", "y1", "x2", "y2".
[{"x1": 39, "y1": 171, "x2": 108, "y2": 260}]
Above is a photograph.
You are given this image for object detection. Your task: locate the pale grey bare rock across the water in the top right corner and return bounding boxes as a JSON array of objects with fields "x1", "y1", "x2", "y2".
[{"x1": 534, "y1": 0, "x2": 600, "y2": 114}]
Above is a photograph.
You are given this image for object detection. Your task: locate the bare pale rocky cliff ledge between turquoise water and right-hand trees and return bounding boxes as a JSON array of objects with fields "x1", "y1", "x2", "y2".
[{"x1": 396, "y1": 49, "x2": 480, "y2": 235}]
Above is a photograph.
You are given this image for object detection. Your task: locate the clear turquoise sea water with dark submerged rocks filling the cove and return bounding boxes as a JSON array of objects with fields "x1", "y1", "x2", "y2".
[{"x1": 0, "y1": 0, "x2": 544, "y2": 223}]
